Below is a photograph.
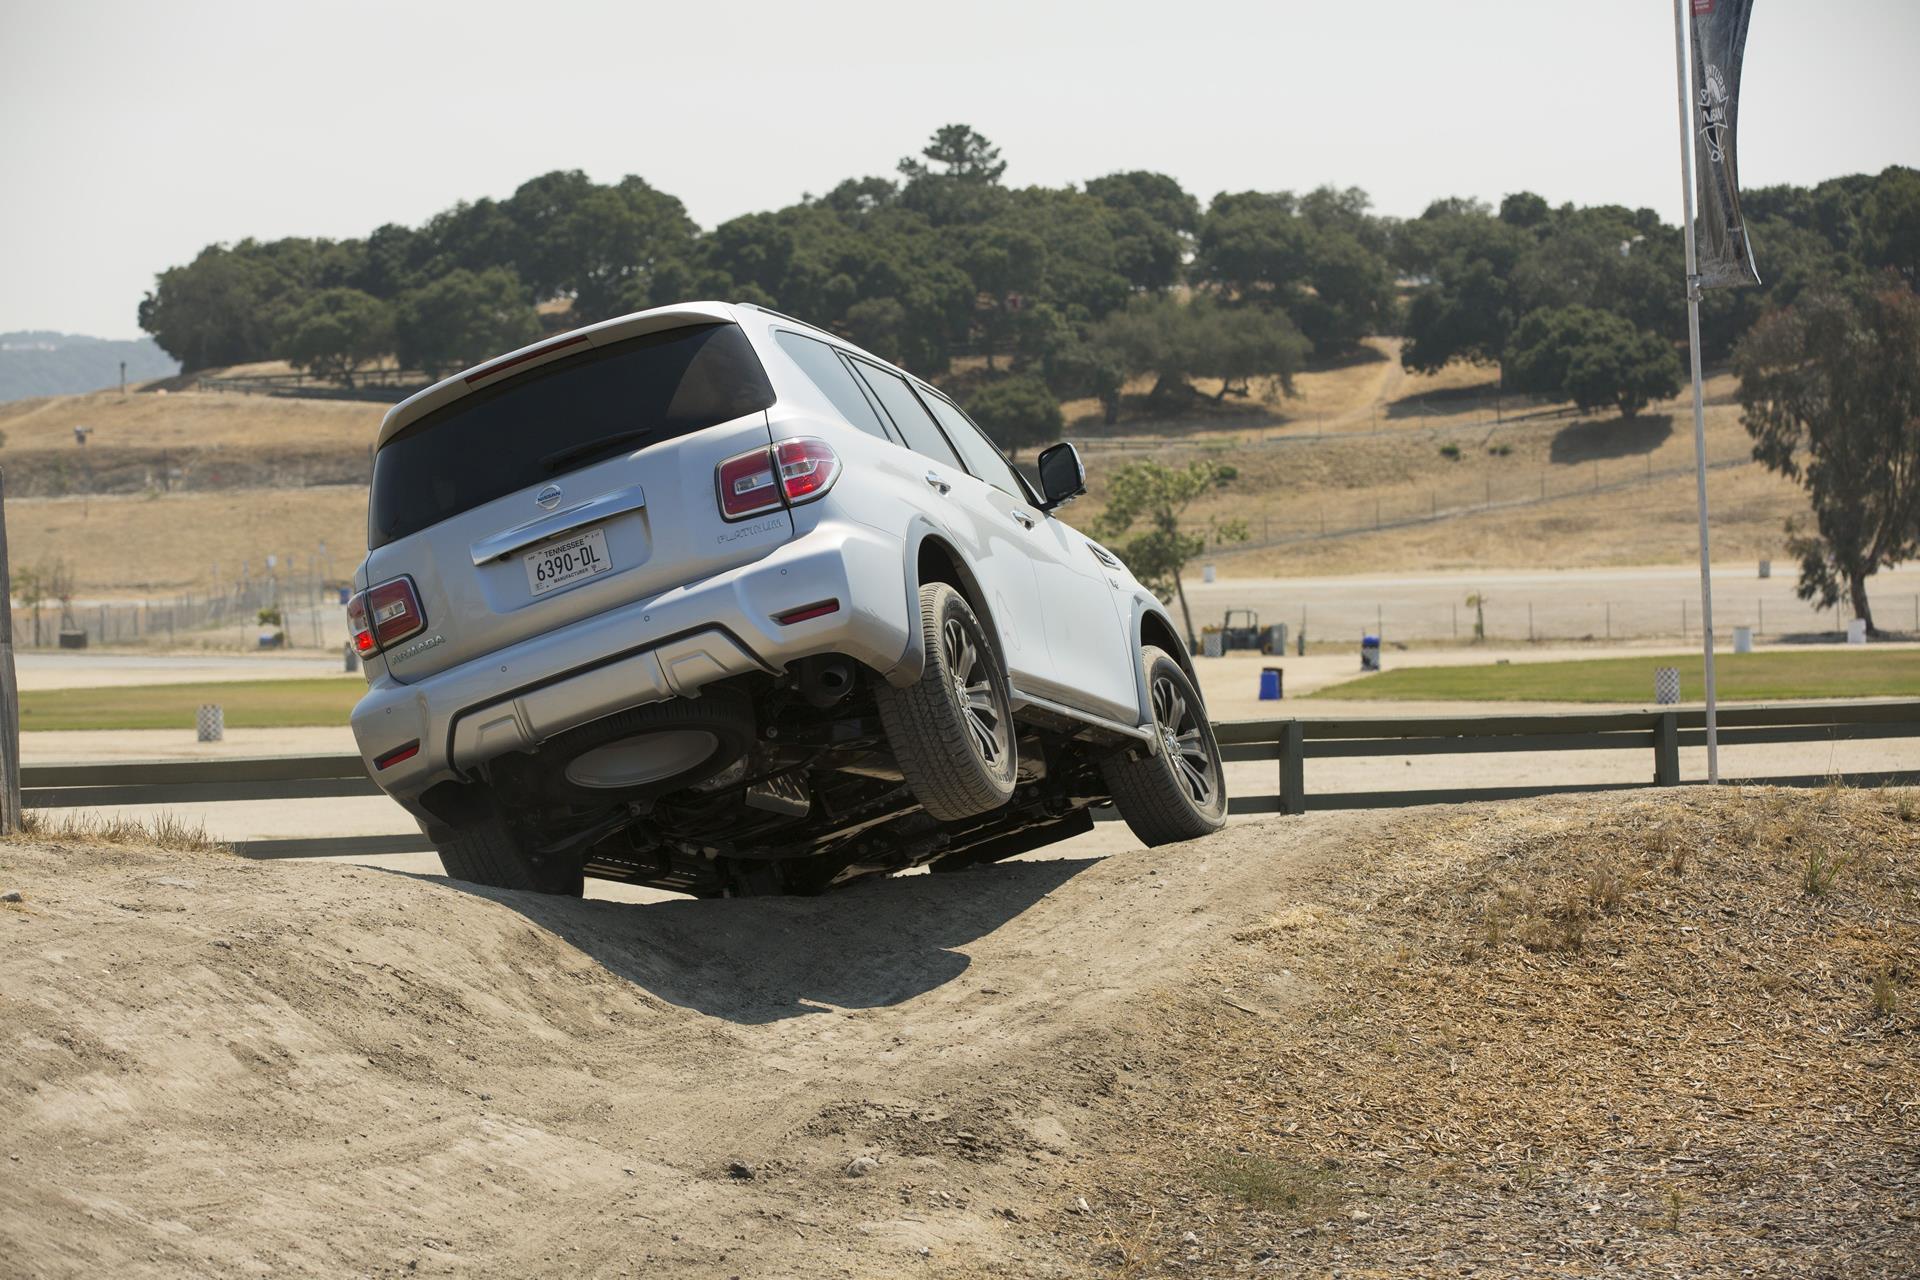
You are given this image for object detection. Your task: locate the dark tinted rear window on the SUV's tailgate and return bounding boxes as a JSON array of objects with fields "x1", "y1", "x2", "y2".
[{"x1": 367, "y1": 324, "x2": 774, "y2": 547}]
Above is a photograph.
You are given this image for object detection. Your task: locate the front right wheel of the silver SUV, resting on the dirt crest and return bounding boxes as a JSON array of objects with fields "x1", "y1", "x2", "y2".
[{"x1": 1100, "y1": 645, "x2": 1227, "y2": 846}]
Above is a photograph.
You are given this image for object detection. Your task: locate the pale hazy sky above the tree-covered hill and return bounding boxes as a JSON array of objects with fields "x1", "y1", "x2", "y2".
[{"x1": 0, "y1": 0, "x2": 1920, "y2": 338}]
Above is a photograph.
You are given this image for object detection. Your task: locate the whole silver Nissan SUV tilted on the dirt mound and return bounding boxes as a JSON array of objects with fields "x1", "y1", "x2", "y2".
[{"x1": 348, "y1": 303, "x2": 1227, "y2": 894}]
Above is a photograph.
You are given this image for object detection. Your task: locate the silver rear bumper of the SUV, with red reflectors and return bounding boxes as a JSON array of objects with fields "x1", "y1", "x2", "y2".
[{"x1": 353, "y1": 522, "x2": 910, "y2": 802}]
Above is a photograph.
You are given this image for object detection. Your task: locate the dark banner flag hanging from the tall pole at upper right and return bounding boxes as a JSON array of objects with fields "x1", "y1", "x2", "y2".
[{"x1": 1690, "y1": 0, "x2": 1761, "y2": 290}]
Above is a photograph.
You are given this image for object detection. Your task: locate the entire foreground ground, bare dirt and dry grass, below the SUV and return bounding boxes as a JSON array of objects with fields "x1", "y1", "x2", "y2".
[{"x1": 0, "y1": 789, "x2": 1920, "y2": 1278}]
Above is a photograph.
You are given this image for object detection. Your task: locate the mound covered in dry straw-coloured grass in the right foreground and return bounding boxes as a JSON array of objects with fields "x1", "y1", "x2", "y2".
[{"x1": 1082, "y1": 789, "x2": 1920, "y2": 1276}]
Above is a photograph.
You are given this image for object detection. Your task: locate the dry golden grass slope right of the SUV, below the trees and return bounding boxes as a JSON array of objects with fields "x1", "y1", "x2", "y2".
[{"x1": 1073, "y1": 365, "x2": 1807, "y2": 578}]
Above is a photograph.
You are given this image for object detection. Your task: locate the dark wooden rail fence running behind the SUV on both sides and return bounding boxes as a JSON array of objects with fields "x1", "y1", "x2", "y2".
[{"x1": 21, "y1": 700, "x2": 1920, "y2": 858}]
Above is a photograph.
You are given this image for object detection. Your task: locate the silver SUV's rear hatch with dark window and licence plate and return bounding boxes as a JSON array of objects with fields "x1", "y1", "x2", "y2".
[{"x1": 367, "y1": 320, "x2": 793, "y2": 681}]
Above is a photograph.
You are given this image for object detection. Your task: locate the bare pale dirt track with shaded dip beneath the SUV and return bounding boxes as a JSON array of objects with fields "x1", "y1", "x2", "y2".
[{"x1": 0, "y1": 814, "x2": 1377, "y2": 1276}]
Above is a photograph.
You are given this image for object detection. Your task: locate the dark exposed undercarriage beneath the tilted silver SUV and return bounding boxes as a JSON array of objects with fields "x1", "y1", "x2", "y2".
[{"x1": 422, "y1": 656, "x2": 1121, "y2": 896}]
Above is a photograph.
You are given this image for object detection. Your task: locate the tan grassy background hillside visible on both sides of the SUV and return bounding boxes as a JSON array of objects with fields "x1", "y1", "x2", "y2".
[{"x1": 0, "y1": 351, "x2": 1805, "y2": 595}]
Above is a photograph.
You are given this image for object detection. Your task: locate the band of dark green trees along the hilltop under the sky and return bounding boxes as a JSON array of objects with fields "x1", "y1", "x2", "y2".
[{"x1": 140, "y1": 125, "x2": 1920, "y2": 429}]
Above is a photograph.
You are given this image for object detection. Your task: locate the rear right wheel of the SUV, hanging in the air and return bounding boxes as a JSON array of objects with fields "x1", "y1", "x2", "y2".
[{"x1": 874, "y1": 581, "x2": 1016, "y2": 821}]
